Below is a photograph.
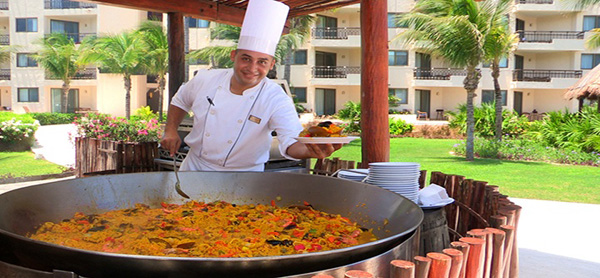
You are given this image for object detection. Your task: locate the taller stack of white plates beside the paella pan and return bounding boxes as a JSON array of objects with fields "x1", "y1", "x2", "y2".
[{"x1": 366, "y1": 162, "x2": 421, "y2": 203}]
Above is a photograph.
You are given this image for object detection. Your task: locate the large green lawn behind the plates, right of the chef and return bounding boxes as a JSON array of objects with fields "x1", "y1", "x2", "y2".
[{"x1": 334, "y1": 138, "x2": 600, "y2": 204}]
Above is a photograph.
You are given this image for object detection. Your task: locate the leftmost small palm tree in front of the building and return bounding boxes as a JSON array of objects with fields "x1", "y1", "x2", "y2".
[{"x1": 34, "y1": 33, "x2": 85, "y2": 113}]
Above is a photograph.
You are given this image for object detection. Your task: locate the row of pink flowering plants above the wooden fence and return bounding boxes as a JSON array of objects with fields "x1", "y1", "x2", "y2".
[{"x1": 74, "y1": 113, "x2": 161, "y2": 142}]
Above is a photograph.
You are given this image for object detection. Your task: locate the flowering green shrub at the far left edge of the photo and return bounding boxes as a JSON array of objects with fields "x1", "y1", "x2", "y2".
[{"x1": 0, "y1": 117, "x2": 39, "y2": 151}]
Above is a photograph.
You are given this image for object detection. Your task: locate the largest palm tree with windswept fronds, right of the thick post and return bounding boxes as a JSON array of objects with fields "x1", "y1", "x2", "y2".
[{"x1": 398, "y1": 0, "x2": 505, "y2": 161}]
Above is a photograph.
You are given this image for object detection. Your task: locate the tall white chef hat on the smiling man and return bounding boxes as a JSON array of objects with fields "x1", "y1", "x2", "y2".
[{"x1": 237, "y1": 0, "x2": 290, "y2": 56}]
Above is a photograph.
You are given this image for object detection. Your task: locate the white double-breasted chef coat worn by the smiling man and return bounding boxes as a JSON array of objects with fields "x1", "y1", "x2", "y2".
[{"x1": 171, "y1": 69, "x2": 302, "y2": 171}]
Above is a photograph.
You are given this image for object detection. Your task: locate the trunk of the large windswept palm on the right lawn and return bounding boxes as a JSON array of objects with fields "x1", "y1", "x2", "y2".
[{"x1": 463, "y1": 66, "x2": 481, "y2": 161}]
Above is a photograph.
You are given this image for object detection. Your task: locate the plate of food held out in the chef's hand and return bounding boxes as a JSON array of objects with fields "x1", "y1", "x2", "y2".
[{"x1": 295, "y1": 121, "x2": 358, "y2": 144}]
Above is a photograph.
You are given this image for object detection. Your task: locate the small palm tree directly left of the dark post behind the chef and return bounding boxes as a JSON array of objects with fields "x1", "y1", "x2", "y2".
[{"x1": 137, "y1": 21, "x2": 169, "y2": 119}]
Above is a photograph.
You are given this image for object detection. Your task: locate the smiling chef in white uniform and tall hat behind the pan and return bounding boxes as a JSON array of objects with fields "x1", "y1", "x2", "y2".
[{"x1": 161, "y1": 0, "x2": 341, "y2": 171}]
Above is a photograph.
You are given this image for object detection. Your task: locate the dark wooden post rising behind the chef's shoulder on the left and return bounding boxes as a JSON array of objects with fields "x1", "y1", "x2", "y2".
[{"x1": 167, "y1": 12, "x2": 185, "y2": 103}]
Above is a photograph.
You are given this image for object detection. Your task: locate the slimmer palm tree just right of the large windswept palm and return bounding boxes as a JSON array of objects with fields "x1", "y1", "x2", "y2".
[{"x1": 483, "y1": 0, "x2": 519, "y2": 141}]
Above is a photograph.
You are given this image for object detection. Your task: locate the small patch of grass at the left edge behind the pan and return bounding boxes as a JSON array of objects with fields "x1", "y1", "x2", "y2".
[{"x1": 0, "y1": 152, "x2": 67, "y2": 178}]
